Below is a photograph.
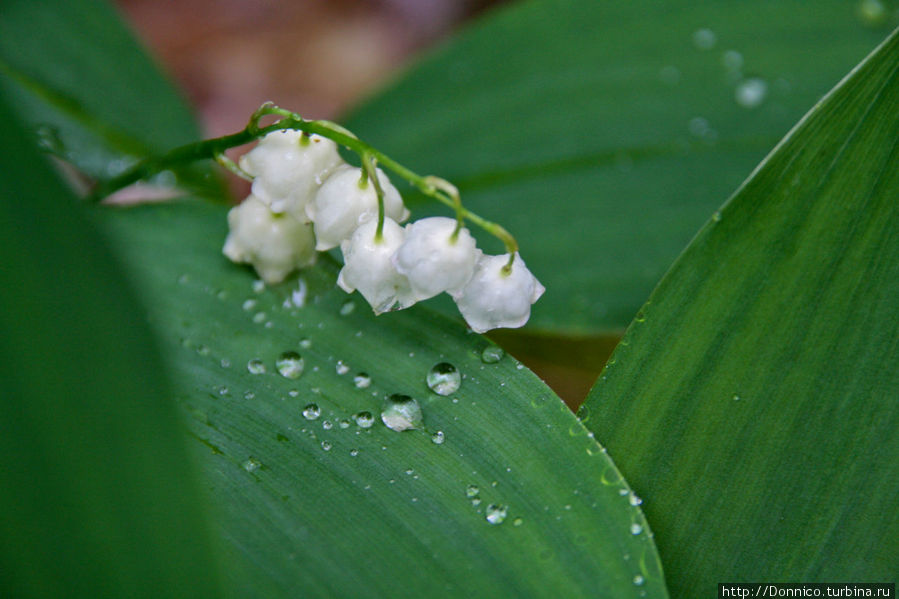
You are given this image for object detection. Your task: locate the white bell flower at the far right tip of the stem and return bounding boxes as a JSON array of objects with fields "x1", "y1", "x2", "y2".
[{"x1": 455, "y1": 252, "x2": 546, "y2": 333}]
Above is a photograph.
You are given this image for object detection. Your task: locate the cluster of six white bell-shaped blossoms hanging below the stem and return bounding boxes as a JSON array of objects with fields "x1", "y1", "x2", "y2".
[{"x1": 223, "y1": 130, "x2": 544, "y2": 333}]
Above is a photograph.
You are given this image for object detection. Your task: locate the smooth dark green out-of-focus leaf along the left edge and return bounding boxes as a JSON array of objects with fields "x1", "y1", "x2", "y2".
[{"x1": 0, "y1": 97, "x2": 220, "y2": 597}]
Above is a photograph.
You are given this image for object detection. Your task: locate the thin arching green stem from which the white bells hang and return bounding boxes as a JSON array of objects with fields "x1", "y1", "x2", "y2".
[{"x1": 87, "y1": 103, "x2": 518, "y2": 255}]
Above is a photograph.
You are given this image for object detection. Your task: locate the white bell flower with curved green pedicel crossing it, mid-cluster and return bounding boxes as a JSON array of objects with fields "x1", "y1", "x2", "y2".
[{"x1": 306, "y1": 165, "x2": 409, "y2": 252}]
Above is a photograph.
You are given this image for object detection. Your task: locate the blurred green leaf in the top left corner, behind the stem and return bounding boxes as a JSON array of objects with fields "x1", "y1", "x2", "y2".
[{"x1": 0, "y1": 0, "x2": 221, "y2": 195}]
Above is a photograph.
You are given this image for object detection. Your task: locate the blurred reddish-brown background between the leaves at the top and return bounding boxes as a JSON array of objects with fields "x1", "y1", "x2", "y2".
[{"x1": 117, "y1": 0, "x2": 508, "y2": 136}]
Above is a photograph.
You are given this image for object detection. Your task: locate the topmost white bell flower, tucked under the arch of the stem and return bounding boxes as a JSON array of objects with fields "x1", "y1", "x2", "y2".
[{"x1": 239, "y1": 129, "x2": 344, "y2": 220}]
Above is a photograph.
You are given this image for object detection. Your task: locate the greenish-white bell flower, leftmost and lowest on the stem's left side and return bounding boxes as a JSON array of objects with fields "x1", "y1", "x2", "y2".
[{"x1": 222, "y1": 194, "x2": 317, "y2": 284}]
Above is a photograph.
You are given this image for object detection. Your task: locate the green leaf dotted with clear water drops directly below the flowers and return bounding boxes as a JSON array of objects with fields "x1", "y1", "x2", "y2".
[{"x1": 104, "y1": 203, "x2": 666, "y2": 597}]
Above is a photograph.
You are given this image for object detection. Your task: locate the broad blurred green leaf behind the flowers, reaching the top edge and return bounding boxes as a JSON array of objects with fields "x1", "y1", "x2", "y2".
[{"x1": 347, "y1": 0, "x2": 883, "y2": 335}]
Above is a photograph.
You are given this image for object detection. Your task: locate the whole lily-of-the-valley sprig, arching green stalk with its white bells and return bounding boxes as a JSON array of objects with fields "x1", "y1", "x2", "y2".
[{"x1": 92, "y1": 103, "x2": 544, "y2": 333}]
